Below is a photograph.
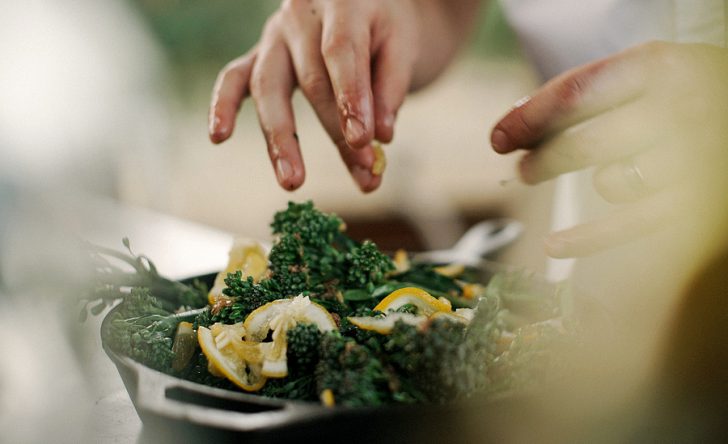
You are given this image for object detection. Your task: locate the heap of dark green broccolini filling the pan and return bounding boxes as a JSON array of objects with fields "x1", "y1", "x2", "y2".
[{"x1": 87, "y1": 202, "x2": 569, "y2": 406}]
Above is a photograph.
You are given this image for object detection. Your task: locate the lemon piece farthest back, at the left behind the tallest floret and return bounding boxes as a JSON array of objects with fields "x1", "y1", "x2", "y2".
[{"x1": 207, "y1": 238, "x2": 268, "y2": 305}]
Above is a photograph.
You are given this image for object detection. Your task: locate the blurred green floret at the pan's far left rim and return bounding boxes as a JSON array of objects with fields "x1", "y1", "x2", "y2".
[{"x1": 107, "y1": 288, "x2": 180, "y2": 370}]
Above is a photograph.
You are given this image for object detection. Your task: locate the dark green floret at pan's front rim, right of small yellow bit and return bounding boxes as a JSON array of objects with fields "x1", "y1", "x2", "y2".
[{"x1": 316, "y1": 332, "x2": 392, "y2": 407}]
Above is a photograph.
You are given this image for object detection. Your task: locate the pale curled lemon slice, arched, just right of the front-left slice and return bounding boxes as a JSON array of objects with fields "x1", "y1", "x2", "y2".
[{"x1": 243, "y1": 296, "x2": 337, "y2": 378}]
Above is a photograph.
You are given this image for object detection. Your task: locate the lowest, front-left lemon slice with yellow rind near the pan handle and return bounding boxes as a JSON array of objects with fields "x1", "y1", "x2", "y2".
[{"x1": 197, "y1": 324, "x2": 266, "y2": 392}]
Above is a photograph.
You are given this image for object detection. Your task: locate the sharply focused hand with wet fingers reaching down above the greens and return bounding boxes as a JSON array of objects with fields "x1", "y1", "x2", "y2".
[{"x1": 209, "y1": 0, "x2": 479, "y2": 192}]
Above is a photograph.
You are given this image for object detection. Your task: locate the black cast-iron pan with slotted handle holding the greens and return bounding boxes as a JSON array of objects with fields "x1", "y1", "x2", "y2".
[{"x1": 101, "y1": 263, "x2": 596, "y2": 443}]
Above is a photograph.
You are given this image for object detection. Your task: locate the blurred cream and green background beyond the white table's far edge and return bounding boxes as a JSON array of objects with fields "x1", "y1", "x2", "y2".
[{"x1": 0, "y1": 0, "x2": 550, "y2": 268}]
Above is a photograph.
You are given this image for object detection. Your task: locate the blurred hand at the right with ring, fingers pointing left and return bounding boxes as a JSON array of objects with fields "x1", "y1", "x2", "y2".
[{"x1": 491, "y1": 42, "x2": 728, "y2": 257}]
